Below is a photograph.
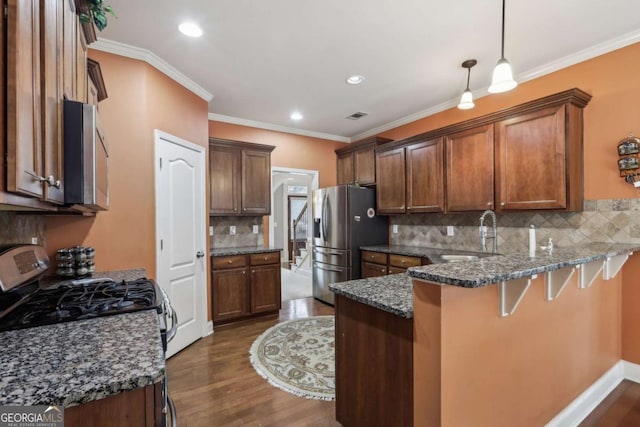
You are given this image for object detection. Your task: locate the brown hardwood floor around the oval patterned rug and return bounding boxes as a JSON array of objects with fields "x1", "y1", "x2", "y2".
[{"x1": 167, "y1": 298, "x2": 340, "y2": 427}]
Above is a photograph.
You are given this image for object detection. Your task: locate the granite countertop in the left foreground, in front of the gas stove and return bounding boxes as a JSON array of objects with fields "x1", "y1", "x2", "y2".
[{"x1": 0, "y1": 310, "x2": 165, "y2": 406}]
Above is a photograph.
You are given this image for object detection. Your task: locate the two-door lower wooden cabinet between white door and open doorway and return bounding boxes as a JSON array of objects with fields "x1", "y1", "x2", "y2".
[{"x1": 211, "y1": 252, "x2": 281, "y2": 324}]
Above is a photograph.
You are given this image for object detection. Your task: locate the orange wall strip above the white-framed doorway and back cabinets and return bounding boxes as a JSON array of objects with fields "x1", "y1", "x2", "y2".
[{"x1": 209, "y1": 119, "x2": 347, "y2": 187}]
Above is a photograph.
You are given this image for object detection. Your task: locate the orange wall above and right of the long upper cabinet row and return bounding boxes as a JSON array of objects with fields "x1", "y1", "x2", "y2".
[{"x1": 379, "y1": 43, "x2": 640, "y2": 199}]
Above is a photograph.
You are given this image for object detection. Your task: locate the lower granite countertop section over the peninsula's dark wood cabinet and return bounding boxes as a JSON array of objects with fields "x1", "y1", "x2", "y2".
[{"x1": 329, "y1": 273, "x2": 413, "y2": 319}]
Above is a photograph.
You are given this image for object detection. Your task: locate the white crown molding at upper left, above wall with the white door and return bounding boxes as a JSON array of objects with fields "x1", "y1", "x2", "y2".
[{"x1": 89, "y1": 38, "x2": 213, "y2": 102}]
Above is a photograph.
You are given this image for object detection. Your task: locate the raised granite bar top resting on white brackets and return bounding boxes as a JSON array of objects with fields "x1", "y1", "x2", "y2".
[{"x1": 409, "y1": 243, "x2": 640, "y2": 288}]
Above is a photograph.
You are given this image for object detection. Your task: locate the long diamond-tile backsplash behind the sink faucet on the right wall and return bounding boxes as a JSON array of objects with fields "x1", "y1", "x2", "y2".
[{"x1": 389, "y1": 199, "x2": 640, "y2": 253}]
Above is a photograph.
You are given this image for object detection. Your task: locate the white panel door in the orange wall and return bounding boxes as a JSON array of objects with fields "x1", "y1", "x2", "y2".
[{"x1": 155, "y1": 130, "x2": 208, "y2": 356}]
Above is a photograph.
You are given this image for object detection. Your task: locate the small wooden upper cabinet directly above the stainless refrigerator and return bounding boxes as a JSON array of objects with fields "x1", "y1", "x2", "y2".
[{"x1": 336, "y1": 137, "x2": 391, "y2": 185}]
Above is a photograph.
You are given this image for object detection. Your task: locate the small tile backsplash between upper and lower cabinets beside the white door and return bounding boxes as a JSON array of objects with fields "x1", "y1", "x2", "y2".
[{"x1": 209, "y1": 216, "x2": 264, "y2": 248}]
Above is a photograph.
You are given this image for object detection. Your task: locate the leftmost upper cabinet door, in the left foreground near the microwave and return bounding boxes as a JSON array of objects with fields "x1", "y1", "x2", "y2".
[{"x1": 6, "y1": 0, "x2": 43, "y2": 197}]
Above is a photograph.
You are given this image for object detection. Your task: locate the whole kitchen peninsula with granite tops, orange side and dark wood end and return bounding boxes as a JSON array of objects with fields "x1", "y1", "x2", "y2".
[{"x1": 331, "y1": 243, "x2": 640, "y2": 426}]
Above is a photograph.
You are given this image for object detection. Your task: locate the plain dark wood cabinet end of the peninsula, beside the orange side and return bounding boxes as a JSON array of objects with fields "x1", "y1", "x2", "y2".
[{"x1": 335, "y1": 295, "x2": 413, "y2": 427}]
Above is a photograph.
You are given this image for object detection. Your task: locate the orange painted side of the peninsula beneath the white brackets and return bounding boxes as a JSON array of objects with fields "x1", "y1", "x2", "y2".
[{"x1": 414, "y1": 274, "x2": 621, "y2": 427}]
